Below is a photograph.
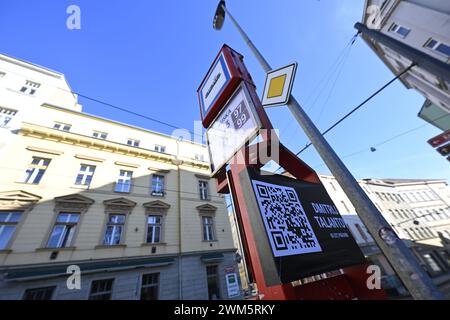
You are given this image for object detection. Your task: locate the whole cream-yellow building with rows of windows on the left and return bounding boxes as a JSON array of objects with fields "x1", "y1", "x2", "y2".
[{"x1": 0, "y1": 54, "x2": 241, "y2": 300}]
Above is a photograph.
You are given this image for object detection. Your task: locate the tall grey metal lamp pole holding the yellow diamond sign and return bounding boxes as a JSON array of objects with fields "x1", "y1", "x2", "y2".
[{"x1": 222, "y1": 5, "x2": 444, "y2": 300}]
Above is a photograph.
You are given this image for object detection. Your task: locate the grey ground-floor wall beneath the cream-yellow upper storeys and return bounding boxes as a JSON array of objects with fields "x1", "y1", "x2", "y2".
[{"x1": 0, "y1": 252, "x2": 240, "y2": 300}]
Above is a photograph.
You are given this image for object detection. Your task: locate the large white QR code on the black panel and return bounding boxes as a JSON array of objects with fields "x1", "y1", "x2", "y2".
[{"x1": 252, "y1": 180, "x2": 322, "y2": 257}]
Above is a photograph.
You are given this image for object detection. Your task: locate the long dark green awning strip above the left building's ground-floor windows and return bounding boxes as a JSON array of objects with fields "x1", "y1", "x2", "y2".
[{"x1": 5, "y1": 258, "x2": 174, "y2": 281}]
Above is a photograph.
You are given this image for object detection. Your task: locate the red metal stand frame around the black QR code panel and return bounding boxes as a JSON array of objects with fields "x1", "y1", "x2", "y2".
[{"x1": 202, "y1": 46, "x2": 387, "y2": 300}]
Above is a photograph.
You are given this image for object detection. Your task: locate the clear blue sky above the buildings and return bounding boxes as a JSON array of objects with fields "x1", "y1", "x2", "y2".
[{"x1": 0, "y1": 0, "x2": 450, "y2": 180}]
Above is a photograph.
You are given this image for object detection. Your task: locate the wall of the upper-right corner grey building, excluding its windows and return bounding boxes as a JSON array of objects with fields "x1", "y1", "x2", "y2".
[{"x1": 363, "y1": 0, "x2": 450, "y2": 125}]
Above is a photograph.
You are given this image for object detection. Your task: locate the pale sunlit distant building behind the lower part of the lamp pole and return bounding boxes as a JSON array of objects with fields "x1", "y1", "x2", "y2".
[{"x1": 320, "y1": 175, "x2": 450, "y2": 291}]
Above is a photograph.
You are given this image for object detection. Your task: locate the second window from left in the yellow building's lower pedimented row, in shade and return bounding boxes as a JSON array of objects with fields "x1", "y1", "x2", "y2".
[{"x1": 47, "y1": 212, "x2": 80, "y2": 248}]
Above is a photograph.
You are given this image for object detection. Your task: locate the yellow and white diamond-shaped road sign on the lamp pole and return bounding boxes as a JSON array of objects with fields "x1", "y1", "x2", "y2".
[{"x1": 261, "y1": 62, "x2": 297, "y2": 107}]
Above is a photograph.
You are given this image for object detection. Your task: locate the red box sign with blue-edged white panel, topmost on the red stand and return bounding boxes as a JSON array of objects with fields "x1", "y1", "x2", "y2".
[{"x1": 197, "y1": 44, "x2": 253, "y2": 128}]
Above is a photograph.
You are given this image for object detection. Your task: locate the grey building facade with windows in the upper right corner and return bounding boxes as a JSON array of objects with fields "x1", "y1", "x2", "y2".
[{"x1": 362, "y1": 0, "x2": 450, "y2": 131}]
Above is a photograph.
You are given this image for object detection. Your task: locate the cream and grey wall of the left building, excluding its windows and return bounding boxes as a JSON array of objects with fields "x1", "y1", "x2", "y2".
[{"x1": 0, "y1": 56, "x2": 239, "y2": 299}]
